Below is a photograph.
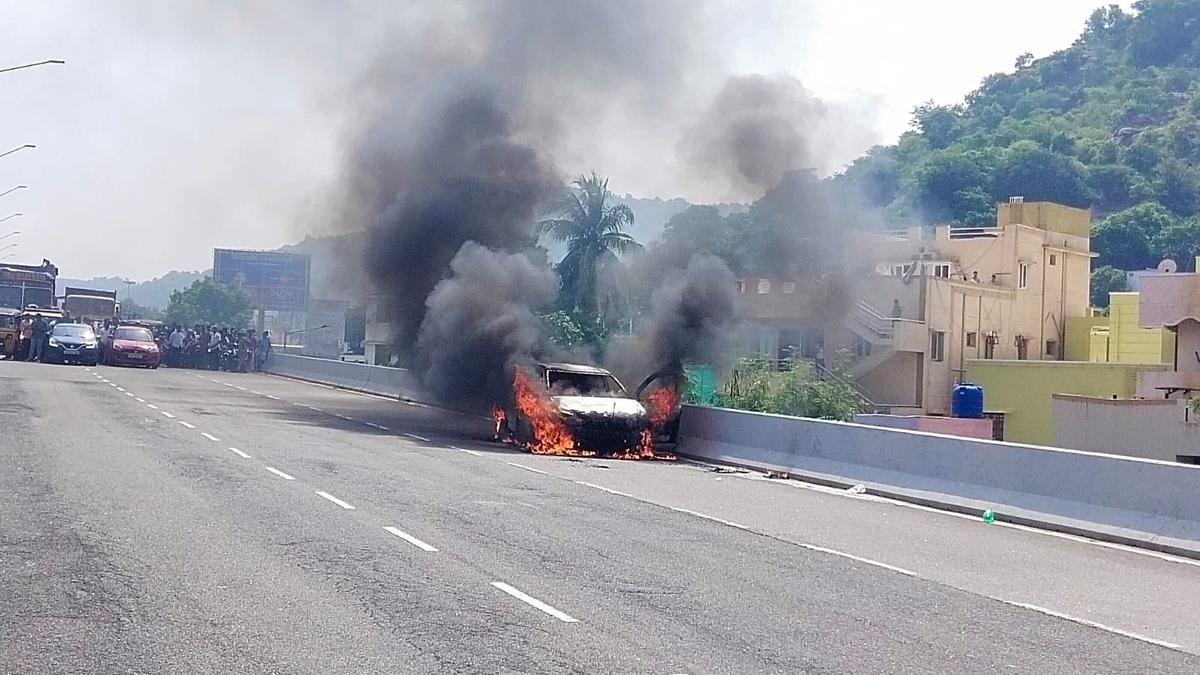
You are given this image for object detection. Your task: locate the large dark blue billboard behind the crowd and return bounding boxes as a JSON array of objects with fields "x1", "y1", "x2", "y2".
[{"x1": 212, "y1": 249, "x2": 310, "y2": 312}]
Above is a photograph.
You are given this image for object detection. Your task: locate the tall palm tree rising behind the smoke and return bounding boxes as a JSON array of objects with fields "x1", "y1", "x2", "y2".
[{"x1": 539, "y1": 172, "x2": 642, "y2": 318}]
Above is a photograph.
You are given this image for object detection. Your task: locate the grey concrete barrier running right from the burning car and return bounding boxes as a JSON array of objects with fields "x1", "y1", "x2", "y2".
[{"x1": 679, "y1": 406, "x2": 1200, "y2": 557}]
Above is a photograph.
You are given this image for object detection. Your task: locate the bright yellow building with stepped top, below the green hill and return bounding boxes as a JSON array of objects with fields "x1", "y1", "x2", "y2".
[{"x1": 1066, "y1": 293, "x2": 1175, "y2": 364}]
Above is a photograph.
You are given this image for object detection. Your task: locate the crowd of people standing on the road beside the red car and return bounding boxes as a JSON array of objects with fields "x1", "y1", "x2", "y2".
[{"x1": 161, "y1": 324, "x2": 271, "y2": 372}]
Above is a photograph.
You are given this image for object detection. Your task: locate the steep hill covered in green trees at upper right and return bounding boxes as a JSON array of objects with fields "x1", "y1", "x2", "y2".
[{"x1": 834, "y1": 0, "x2": 1200, "y2": 304}]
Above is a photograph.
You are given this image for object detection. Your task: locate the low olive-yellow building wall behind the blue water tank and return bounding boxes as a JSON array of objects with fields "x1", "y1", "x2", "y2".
[{"x1": 966, "y1": 359, "x2": 1170, "y2": 446}]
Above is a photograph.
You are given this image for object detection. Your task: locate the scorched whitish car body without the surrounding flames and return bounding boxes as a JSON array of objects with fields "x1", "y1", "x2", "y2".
[{"x1": 505, "y1": 363, "x2": 650, "y2": 454}]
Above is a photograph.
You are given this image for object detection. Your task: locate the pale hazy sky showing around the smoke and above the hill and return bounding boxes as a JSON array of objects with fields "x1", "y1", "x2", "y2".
[{"x1": 0, "y1": 0, "x2": 1123, "y2": 280}]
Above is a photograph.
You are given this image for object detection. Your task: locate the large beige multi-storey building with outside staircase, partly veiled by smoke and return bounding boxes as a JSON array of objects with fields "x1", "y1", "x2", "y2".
[{"x1": 738, "y1": 197, "x2": 1093, "y2": 414}]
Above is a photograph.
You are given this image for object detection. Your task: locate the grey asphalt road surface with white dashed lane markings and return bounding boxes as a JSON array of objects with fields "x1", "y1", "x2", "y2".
[{"x1": 0, "y1": 362, "x2": 1200, "y2": 674}]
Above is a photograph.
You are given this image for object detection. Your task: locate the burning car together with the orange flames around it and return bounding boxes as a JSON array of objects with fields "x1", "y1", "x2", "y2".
[{"x1": 492, "y1": 364, "x2": 678, "y2": 459}]
